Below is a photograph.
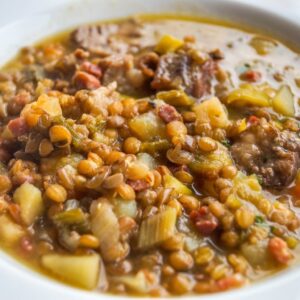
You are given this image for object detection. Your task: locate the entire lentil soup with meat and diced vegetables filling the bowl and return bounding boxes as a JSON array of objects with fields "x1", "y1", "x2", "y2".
[{"x1": 0, "y1": 16, "x2": 300, "y2": 296}]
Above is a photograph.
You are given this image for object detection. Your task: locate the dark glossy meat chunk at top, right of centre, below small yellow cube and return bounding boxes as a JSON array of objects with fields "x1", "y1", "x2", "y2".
[{"x1": 151, "y1": 53, "x2": 216, "y2": 98}]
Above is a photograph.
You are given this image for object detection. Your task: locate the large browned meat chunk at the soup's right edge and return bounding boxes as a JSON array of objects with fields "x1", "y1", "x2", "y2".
[{"x1": 231, "y1": 119, "x2": 300, "y2": 187}]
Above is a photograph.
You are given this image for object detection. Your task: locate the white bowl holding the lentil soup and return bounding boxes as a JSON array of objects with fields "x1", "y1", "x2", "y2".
[{"x1": 0, "y1": 0, "x2": 300, "y2": 300}]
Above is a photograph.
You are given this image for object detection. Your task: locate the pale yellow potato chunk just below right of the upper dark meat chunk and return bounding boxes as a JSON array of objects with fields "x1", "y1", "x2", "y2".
[{"x1": 193, "y1": 97, "x2": 229, "y2": 128}]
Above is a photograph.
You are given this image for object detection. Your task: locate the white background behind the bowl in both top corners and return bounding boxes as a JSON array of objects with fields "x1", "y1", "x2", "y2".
[{"x1": 0, "y1": 0, "x2": 300, "y2": 26}]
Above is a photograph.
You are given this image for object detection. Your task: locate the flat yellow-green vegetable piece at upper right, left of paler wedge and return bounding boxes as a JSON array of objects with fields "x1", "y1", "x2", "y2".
[{"x1": 226, "y1": 84, "x2": 270, "y2": 107}]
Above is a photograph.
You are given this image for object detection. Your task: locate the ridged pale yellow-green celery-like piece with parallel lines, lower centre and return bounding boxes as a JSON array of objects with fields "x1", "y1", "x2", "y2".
[{"x1": 138, "y1": 207, "x2": 176, "y2": 249}]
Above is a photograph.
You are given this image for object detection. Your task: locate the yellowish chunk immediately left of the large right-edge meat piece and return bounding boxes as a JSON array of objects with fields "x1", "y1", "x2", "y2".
[{"x1": 189, "y1": 144, "x2": 232, "y2": 179}]
